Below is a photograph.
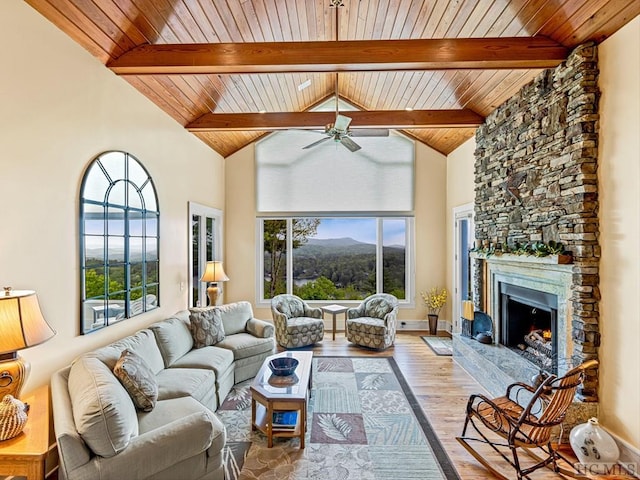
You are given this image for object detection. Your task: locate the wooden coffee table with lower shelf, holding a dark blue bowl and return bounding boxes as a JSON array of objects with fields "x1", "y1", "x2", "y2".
[{"x1": 250, "y1": 351, "x2": 313, "y2": 448}]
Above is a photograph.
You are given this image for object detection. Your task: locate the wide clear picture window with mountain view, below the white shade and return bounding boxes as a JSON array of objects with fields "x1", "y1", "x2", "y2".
[{"x1": 258, "y1": 217, "x2": 413, "y2": 302}]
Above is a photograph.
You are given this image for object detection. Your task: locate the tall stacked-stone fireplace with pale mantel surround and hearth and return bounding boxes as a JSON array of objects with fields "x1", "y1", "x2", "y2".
[{"x1": 453, "y1": 44, "x2": 600, "y2": 432}]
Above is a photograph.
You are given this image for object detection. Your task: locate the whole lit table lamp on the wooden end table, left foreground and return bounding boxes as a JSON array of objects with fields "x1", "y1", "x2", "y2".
[{"x1": 0, "y1": 287, "x2": 56, "y2": 400}]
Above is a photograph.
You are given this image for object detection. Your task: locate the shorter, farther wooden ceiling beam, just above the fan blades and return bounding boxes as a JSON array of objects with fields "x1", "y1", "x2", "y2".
[{"x1": 186, "y1": 110, "x2": 484, "y2": 132}]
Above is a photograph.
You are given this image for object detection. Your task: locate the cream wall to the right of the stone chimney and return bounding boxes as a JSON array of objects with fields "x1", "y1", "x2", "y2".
[{"x1": 598, "y1": 17, "x2": 640, "y2": 450}]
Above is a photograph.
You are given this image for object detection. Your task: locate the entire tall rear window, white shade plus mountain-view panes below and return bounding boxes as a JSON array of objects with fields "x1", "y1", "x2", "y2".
[{"x1": 255, "y1": 101, "x2": 415, "y2": 304}]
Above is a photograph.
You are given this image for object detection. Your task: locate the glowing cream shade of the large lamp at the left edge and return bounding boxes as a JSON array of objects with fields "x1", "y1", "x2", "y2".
[{"x1": 0, "y1": 289, "x2": 56, "y2": 356}]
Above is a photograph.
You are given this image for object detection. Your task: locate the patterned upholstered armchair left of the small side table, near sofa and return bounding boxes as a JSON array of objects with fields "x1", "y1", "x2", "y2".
[{"x1": 271, "y1": 294, "x2": 324, "y2": 348}]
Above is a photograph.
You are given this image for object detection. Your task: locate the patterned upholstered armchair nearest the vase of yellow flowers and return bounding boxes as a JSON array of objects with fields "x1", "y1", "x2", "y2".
[{"x1": 347, "y1": 293, "x2": 398, "y2": 350}]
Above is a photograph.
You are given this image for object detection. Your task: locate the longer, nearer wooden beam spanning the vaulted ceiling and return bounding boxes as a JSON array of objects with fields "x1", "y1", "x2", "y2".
[{"x1": 108, "y1": 37, "x2": 569, "y2": 75}]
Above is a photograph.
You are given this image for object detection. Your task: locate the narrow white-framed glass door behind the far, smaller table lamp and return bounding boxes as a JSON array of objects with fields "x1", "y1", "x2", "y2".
[{"x1": 189, "y1": 202, "x2": 222, "y2": 307}]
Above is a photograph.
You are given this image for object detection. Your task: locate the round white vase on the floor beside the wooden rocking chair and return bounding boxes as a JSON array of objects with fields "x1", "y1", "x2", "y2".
[{"x1": 569, "y1": 418, "x2": 620, "y2": 473}]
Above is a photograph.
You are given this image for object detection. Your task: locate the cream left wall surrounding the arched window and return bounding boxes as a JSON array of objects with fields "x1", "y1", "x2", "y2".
[{"x1": 0, "y1": 0, "x2": 224, "y2": 392}]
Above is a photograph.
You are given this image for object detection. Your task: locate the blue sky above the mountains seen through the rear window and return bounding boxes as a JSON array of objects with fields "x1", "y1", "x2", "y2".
[{"x1": 315, "y1": 218, "x2": 405, "y2": 245}]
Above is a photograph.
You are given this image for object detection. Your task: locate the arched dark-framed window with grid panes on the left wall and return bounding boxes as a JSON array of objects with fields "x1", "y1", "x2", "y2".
[{"x1": 80, "y1": 151, "x2": 160, "y2": 333}]
